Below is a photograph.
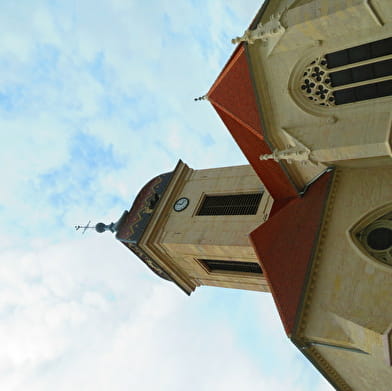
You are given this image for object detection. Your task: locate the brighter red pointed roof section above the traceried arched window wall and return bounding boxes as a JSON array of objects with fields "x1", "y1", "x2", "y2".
[{"x1": 208, "y1": 45, "x2": 298, "y2": 200}]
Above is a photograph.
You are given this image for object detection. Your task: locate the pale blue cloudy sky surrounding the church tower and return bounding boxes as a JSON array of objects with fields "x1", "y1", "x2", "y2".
[{"x1": 0, "y1": 0, "x2": 333, "y2": 391}]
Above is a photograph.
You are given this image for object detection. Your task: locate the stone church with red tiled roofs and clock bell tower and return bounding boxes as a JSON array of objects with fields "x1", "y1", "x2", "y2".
[{"x1": 96, "y1": 0, "x2": 392, "y2": 391}]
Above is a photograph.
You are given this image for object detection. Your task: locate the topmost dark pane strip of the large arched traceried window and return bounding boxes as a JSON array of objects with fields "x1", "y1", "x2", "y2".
[{"x1": 325, "y1": 38, "x2": 392, "y2": 69}]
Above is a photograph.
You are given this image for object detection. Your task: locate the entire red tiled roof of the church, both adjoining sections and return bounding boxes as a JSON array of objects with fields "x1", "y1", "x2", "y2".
[{"x1": 208, "y1": 39, "x2": 332, "y2": 335}]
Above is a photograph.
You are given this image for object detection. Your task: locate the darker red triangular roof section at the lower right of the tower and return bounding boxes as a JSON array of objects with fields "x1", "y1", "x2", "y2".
[{"x1": 250, "y1": 173, "x2": 333, "y2": 336}]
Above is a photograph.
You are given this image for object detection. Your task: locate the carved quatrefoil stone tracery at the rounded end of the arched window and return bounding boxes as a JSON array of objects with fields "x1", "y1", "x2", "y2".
[{"x1": 300, "y1": 57, "x2": 335, "y2": 107}]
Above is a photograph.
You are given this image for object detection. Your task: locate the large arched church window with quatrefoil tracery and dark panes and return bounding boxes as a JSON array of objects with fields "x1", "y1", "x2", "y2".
[{"x1": 301, "y1": 38, "x2": 392, "y2": 106}]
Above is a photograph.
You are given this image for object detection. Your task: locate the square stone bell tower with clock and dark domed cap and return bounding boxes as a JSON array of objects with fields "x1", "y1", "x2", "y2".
[{"x1": 97, "y1": 161, "x2": 273, "y2": 294}]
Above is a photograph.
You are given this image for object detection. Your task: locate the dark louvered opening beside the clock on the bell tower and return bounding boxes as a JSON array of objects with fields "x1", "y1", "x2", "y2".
[{"x1": 197, "y1": 193, "x2": 263, "y2": 216}]
